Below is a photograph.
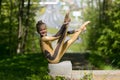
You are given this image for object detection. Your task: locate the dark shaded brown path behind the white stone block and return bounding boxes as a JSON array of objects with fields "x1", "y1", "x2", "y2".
[{"x1": 62, "y1": 53, "x2": 97, "y2": 70}]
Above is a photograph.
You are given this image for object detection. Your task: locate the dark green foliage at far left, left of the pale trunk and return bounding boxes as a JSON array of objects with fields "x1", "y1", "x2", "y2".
[{"x1": 0, "y1": 0, "x2": 17, "y2": 53}]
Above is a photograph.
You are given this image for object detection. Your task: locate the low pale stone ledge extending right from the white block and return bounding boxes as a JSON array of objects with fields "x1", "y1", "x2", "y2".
[{"x1": 71, "y1": 70, "x2": 120, "y2": 80}]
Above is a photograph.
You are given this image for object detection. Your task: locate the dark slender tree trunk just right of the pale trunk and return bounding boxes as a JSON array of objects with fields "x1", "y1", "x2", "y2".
[{"x1": 23, "y1": 0, "x2": 30, "y2": 53}]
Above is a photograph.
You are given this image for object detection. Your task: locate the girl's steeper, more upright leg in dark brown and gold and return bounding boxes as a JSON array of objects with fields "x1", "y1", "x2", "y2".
[{"x1": 45, "y1": 13, "x2": 70, "y2": 63}]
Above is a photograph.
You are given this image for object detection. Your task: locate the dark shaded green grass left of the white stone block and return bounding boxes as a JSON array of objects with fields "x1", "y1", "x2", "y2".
[{"x1": 0, "y1": 53, "x2": 48, "y2": 80}]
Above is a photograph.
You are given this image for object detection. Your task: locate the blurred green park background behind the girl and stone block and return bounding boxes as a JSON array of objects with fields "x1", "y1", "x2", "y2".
[{"x1": 0, "y1": 0, "x2": 120, "y2": 80}]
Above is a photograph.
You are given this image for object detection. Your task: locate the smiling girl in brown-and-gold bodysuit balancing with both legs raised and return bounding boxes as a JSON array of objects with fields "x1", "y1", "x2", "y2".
[{"x1": 36, "y1": 12, "x2": 90, "y2": 63}]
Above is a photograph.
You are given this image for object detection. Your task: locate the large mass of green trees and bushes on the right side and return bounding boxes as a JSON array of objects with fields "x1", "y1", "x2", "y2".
[{"x1": 84, "y1": 0, "x2": 120, "y2": 69}]
